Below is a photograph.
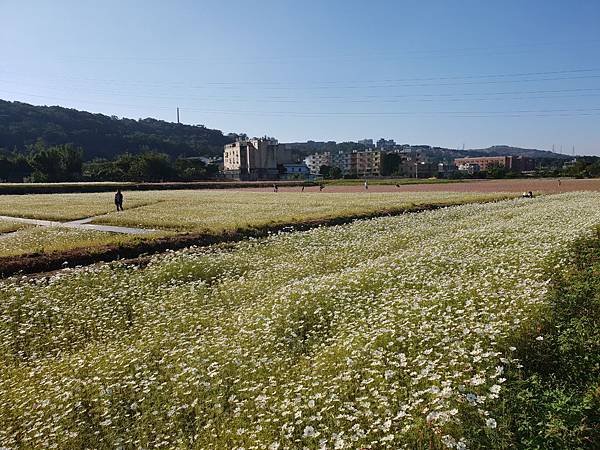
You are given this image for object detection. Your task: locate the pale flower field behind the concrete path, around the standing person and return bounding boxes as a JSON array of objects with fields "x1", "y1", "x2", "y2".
[{"x1": 0, "y1": 188, "x2": 508, "y2": 231}]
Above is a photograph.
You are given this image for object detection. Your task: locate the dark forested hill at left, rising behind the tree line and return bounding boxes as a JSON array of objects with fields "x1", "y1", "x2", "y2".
[{"x1": 0, "y1": 100, "x2": 233, "y2": 159}]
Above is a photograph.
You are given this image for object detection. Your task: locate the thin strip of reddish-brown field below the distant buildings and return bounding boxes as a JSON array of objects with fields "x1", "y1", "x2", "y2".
[{"x1": 245, "y1": 178, "x2": 600, "y2": 194}]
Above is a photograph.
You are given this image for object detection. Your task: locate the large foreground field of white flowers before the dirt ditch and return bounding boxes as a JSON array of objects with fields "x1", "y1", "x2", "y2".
[{"x1": 0, "y1": 193, "x2": 600, "y2": 450}]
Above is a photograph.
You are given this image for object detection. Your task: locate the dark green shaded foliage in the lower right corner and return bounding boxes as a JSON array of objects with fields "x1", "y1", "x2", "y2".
[{"x1": 490, "y1": 231, "x2": 600, "y2": 449}]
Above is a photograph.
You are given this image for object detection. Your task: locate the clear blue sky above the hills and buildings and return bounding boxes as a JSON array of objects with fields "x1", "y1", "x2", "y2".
[{"x1": 0, "y1": 0, "x2": 600, "y2": 155}]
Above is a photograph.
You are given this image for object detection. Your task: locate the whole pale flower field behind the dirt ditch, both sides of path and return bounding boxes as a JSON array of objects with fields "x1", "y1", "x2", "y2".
[{"x1": 0, "y1": 190, "x2": 510, "y2": 256}]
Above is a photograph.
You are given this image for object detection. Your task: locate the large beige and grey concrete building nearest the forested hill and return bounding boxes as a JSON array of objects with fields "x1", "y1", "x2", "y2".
[{"x1": 223, "y1": 137, "x2": 279, "y2": 181}]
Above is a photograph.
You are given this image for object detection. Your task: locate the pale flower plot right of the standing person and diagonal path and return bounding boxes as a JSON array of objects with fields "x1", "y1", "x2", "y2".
[{"x1": 90, "y1": 191, "x2": 510, "y2": 233}]
